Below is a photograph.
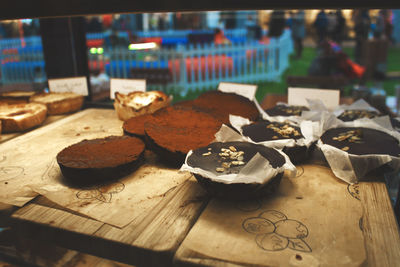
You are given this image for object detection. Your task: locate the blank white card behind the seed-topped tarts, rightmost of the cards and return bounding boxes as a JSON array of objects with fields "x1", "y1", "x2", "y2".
[{"x1": 288, "y1": 87, "x2": 340, "y2": 109}]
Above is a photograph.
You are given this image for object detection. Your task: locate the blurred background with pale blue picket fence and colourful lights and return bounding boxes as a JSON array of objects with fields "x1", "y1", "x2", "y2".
[{"x1": 0, "y1": 9, "x2": 400, "y2": 109}]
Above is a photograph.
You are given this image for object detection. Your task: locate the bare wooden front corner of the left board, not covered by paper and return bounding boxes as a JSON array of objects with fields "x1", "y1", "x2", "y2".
[{"x1": 12, "y1": 179, "x2": 206, "y2": 266}]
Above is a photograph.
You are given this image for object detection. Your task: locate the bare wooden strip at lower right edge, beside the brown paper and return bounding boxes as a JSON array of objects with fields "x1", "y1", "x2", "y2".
[{"x1": 359, "y1": 180, "x2": 400, "y2": 266}]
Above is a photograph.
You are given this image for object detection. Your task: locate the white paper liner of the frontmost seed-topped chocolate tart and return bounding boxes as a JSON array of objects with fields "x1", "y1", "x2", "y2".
[{"x1": 180, "y1": 124, "x2": 296, "y2": 184}]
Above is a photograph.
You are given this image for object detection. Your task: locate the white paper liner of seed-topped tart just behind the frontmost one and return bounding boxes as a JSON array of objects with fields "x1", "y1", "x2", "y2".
[{"x1": 229, "y1": 115, "x2": 319, "y2": 149}]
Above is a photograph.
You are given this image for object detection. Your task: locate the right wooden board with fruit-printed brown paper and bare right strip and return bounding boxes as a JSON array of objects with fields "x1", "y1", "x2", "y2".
[{"x1": 174, "y1": 165, "x2": 400, "y2": 266}]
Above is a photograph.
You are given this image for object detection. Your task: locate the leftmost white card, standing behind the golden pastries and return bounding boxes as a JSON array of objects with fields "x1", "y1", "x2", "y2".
[{"x1": 48, "y1": 76, "x2": 89, "y2": 95}]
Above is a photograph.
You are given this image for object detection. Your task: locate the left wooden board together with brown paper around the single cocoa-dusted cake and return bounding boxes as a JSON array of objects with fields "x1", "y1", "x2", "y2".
[{"x1": 5, "y1": 109, "x2": 206, "y2": 266}]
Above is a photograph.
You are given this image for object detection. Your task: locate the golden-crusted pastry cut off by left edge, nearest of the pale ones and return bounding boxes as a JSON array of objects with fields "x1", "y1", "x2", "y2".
[{"x1": 0, "y1": 103, "x2": 47, "y2": 133}]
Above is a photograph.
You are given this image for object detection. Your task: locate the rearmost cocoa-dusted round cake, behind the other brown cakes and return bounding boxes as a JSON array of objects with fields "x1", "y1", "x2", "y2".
[{"x1": 190, "y1": 91, "x2": 260, "y2": 125}]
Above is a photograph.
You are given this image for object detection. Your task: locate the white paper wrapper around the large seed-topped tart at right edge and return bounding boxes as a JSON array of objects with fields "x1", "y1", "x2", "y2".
[{"x1": 314, "y1": 113, "x2": 400, "y2": 184}]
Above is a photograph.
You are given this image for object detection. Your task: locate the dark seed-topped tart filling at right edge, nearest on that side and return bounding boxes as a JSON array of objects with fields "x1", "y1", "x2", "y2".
[{"x1": 321, "y1": 127, "x2": 400, "y2": 157}]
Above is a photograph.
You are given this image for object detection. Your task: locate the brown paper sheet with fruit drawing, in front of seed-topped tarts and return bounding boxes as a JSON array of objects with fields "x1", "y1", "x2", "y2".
[{"x1": 174, "y1": 165, "x2": 374, "y2": 267}]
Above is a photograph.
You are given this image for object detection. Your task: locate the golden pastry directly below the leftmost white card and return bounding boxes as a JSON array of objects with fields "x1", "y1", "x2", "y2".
[{"x1": 30, "y1": 92, "x2": 84, "y2": 115}]
